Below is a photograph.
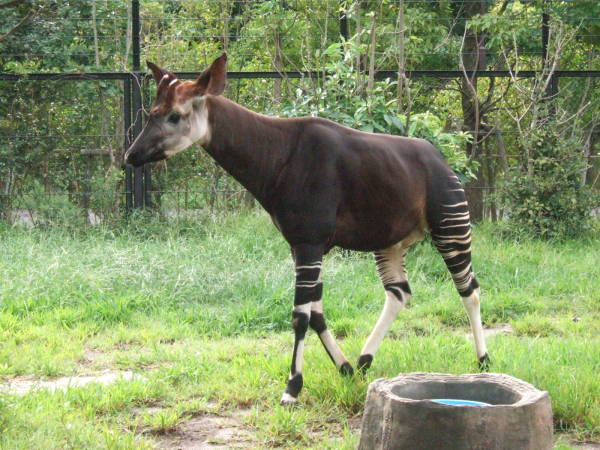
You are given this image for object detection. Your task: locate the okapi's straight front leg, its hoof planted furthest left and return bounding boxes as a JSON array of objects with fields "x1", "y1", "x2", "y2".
[{"x1": 281, "y1": 245, "x2": 323, "y2": 405}]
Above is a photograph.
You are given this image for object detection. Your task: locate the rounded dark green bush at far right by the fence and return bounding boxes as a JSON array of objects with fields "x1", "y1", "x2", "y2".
[{"x1": 502, "y1": 123, "x2": 598, "y2": 238}]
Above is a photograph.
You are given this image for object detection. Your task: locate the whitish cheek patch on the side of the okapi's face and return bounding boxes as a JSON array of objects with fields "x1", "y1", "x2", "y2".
[{"x1": 165, "y1": 99, "x2": 210, "y2": 158}]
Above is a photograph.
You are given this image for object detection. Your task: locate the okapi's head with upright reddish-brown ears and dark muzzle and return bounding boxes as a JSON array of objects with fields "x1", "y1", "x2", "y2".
[{"x1": 125, "y1": 53, "x2": 227, "y2": 167}]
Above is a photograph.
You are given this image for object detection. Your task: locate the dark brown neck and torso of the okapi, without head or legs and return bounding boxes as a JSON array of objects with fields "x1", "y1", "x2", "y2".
[{"x1": 206, "y1": 96, "x2": 452, "y2": 251}]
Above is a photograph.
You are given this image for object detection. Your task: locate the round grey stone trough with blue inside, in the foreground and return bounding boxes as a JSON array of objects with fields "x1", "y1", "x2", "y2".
[{"x1": 359, "y1": 373, "x2": 553, "y2": 450}]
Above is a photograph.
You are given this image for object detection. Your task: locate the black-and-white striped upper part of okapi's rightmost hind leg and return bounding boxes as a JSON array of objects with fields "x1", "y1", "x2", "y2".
[{"x1": 429, "y1": 175, "x2": 479, "y2": 298}]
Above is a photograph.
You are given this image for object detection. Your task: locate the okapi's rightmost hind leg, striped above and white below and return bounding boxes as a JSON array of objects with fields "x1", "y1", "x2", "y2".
[{"x1": 431, "y1": 181, "x2": 490, "y2": 371}]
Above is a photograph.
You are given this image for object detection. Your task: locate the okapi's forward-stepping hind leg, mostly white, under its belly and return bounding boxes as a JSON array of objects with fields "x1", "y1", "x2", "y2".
[{"x1": 357, "y1": 243, "x2": 411, "y2": 374}]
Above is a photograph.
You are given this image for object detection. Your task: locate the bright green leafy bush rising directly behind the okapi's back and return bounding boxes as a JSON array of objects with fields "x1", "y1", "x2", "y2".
[{"x1": 279, "y1": 41, "x2": 477, "y2": 181}]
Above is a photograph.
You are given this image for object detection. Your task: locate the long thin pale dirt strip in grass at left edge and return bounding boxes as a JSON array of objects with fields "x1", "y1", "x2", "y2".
[{"x1": 0, "y1": 370, "x2": 143, "y2": 395}]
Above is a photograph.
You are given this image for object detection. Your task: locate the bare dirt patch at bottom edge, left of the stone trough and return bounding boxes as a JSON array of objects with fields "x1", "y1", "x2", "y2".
[{"x1": 155, "y1": 410, "x2": 257, "y2": 450}]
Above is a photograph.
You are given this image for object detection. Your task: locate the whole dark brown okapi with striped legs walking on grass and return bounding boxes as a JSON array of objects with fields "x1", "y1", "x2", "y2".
[{"x1": 125, "y1": 54, "x2": 488, "y2": 404}]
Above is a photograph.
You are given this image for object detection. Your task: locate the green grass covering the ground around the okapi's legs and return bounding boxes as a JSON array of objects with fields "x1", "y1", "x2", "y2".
[{"x1": 0, "y1": 213, "x2": 600, "y2": 449}]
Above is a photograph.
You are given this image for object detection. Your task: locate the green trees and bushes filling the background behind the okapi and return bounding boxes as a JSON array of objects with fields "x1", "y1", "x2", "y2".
[{"x1": 0, "y1": 0, "x2": 600, "y2": 236}]
